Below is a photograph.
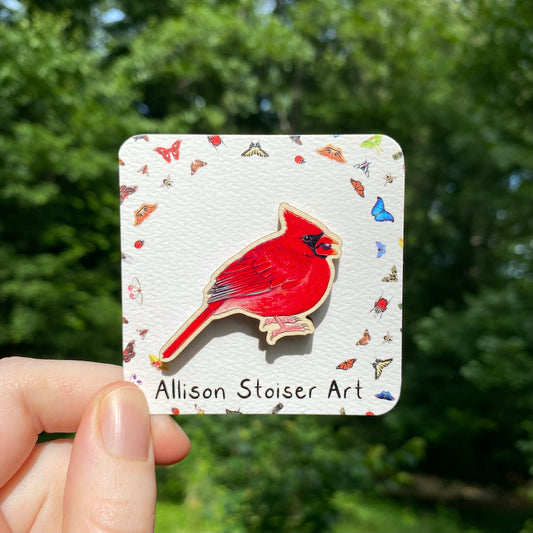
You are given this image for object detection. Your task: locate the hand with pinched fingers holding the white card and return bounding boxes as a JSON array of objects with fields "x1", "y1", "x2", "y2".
[{"x1": 0, "y1": 357, "x2": 190, "y2": 533}]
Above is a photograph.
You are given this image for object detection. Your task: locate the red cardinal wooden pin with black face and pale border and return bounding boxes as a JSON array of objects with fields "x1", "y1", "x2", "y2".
[{"x1": 160, "y1": 203, "x2": 342, "y2": 361}]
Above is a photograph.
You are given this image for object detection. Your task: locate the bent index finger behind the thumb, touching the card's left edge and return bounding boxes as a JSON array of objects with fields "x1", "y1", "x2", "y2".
[{"x1": 0, "y1": 357, "x2": 122, "y2": 486}]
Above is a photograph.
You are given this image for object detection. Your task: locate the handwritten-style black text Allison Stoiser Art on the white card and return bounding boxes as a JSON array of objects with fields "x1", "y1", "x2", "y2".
[{"x1": 155, "y1": 378, "x2": 363, "y2": 400}]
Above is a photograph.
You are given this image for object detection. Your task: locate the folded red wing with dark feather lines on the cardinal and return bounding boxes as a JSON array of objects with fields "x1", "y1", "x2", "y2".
[{"x1": 208, "y1": 243, "x2": 288, "y2": 303}]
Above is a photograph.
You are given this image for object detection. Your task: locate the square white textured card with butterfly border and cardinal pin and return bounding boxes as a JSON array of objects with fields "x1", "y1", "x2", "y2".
[{"x1": 119, "y1": 134, "x2": 405, "y2": 415}]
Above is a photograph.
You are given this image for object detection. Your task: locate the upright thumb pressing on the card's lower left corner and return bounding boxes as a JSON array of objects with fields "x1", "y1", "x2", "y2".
[{"x1": 63, "y1": 382, "x2": 156, "y2": 533}]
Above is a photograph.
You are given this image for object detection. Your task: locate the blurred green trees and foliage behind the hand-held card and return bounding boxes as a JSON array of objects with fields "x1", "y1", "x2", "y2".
[{"x1": 0, "y1": 0, "x2": 533, "y2": 533}]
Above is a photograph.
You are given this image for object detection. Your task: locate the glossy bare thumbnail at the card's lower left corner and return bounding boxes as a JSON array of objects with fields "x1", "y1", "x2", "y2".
[{"x1": 100, "y1": 387, "x2": 150, "y2": 460}]
